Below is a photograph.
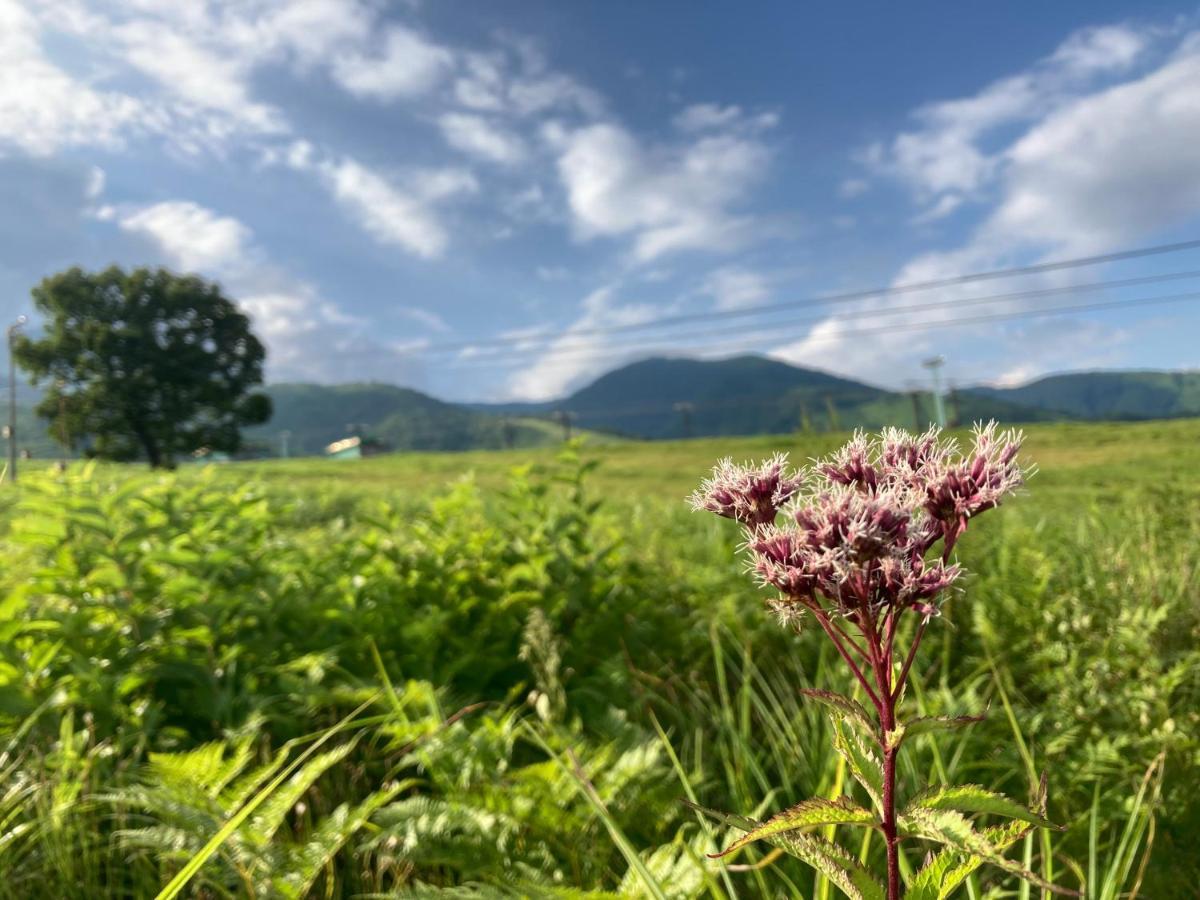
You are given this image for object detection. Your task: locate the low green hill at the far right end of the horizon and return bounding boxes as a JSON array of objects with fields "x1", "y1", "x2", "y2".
[{"x1": 972, "y1": 372, "x2": 1200, "y2": 420}]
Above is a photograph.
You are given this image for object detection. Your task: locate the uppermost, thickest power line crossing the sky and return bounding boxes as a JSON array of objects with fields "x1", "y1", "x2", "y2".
[{"x1": 408, "y1": 239, "x2": 1200, "y2": 353}]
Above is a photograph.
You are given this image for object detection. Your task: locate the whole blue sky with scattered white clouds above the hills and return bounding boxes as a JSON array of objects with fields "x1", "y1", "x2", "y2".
[{"x1": 0, "y1": 0, "x2": 1200, "y2": 400}]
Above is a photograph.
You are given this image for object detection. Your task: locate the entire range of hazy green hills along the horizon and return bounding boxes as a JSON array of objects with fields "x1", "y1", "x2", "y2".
[{"x1": 11, "y1": 356, "x2": 1200, "y2": 458}]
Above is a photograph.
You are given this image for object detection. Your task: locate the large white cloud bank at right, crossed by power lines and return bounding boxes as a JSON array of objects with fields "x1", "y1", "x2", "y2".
[{"x1": 775, "y1": 24, "x2": 1200, "y2": 384}]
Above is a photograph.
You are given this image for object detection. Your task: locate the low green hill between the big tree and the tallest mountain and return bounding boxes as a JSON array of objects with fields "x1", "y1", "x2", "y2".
[{"x1": 245, "y1": 384, "x2": 573, "y2": 456}]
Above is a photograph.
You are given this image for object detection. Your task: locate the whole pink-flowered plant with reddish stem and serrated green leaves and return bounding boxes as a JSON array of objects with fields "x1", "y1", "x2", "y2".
[{"x1": 691, "y1": 422, "x2": 1073, "y2": 900}]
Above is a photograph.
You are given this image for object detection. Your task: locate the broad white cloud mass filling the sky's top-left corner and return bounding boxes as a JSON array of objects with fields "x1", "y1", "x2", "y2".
[{"x1": 0, "y1": 0, "x2": 455, "y2": 154}]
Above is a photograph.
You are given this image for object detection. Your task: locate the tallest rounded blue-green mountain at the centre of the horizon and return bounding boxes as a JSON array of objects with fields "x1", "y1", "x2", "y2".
[{"x1": 485, "y1": 356, "x2": 1062, "y2": 439}]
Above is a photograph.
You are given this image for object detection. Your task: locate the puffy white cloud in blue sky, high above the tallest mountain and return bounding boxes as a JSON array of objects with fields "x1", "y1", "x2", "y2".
[{"x1": 548, "y1": 124, "x2": 770, "y2": 262}]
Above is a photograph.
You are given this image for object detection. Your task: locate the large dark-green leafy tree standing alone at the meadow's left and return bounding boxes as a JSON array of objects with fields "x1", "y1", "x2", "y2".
[{"x1": 14, "y1": 266, "x2": 271, "y2": 467}]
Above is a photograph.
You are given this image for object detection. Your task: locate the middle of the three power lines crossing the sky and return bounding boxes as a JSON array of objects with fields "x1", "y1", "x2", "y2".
[{"x1": 448, "y1": 269, "x2": 1200, "y2": 361}]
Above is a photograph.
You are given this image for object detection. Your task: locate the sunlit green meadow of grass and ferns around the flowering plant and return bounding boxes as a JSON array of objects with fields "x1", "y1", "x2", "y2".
[{"x1": 0, "y1": 420, "x2": 1200, "y2": 900}]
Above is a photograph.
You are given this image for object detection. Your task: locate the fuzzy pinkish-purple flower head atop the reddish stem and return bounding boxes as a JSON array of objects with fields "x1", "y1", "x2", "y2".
[{"x1": 692, "y1": 422, "x2": 1024, "y2": 630}]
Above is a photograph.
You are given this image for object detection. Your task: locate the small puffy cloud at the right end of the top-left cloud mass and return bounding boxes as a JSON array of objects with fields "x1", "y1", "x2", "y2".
[{"x1": 332, "y1": 25, "x2": 454, "y2": 101}]
